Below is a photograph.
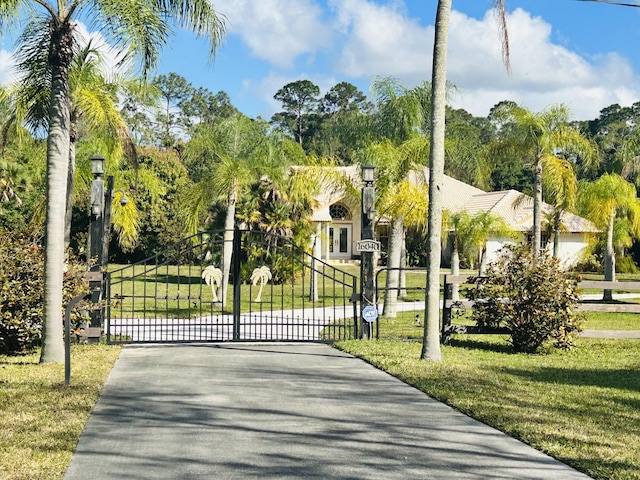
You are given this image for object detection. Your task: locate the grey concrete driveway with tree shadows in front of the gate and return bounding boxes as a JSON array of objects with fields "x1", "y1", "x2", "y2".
[{"x1": 64, "y1": 343, "x2": 589, "y2": 480}]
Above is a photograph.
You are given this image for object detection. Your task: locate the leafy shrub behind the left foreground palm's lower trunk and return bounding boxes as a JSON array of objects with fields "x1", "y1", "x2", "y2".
[{"x1": 0, "y1": 232, "x2": 86, "y2": 355}]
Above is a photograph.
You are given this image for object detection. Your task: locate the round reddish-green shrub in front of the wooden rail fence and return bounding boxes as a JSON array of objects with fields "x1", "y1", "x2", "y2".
[{"x1": 465, "y1": 245, "x2": 583, "y2": 353}]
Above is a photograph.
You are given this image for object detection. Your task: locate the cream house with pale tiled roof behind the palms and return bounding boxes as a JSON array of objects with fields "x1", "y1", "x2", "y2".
[{"x1": 312, "y1": 166, "x2": 598, "y2": 264}]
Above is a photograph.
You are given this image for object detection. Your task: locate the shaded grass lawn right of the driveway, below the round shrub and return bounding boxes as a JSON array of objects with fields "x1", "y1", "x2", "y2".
[{"x1": 335, "y1": 314, "x2": 640, "y2": 479}]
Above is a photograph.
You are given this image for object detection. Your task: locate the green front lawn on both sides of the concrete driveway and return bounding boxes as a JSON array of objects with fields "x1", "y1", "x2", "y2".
[{"x1": 0, "y1": 275, "x2": 640, "y2": 480}]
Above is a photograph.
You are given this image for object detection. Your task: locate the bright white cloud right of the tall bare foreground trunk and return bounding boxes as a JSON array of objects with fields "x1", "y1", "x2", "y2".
[{"x1": 448, "y1": 9, "x2": 640, "y2": 119}]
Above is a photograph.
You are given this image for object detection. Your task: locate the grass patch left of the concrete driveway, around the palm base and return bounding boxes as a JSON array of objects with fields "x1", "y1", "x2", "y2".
[{"x1": 0, "y1": 345, "x2": 120, "y2": 480}]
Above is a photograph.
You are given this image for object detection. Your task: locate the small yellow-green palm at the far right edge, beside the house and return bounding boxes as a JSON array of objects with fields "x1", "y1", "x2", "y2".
[{"x1": 578, "y1": 173, "x2": 640, "y2": 300}]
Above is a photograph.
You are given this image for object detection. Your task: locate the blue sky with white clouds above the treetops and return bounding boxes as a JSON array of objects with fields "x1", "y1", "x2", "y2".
[{"x1": 0, "y1": 0, "x2": 640, "y2": 119}]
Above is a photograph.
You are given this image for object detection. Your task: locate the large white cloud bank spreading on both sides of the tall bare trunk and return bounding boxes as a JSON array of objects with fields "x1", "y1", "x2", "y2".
[{"x1": 294, "y1": 0, "x2": 640, "y2": 119}]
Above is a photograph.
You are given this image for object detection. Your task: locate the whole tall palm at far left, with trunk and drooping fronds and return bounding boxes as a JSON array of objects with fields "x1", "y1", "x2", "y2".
[{"x1": 0, "y1": 0, "x2": 224, "y2": 363}]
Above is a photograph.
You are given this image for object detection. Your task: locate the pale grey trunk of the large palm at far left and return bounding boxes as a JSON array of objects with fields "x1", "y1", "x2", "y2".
[{"x1": 40, "y1": 23, "x2": 73, "y2": 363}]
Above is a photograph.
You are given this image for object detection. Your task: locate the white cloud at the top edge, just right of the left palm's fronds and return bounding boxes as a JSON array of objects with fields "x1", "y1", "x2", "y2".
[{"x1": 219, "y1": 0, "x2": 331, "y2": 68}]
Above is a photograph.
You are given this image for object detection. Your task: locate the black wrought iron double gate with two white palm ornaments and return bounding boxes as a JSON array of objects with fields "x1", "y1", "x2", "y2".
[{"x1": 105, "y1": 230, "x2": 358, "y2": 343}]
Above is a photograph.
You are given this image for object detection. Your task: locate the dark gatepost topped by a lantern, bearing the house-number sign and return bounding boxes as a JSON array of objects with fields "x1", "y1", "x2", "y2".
[{"x1": 360, "y1": 164, "x2": 377, "y2": 339}]
